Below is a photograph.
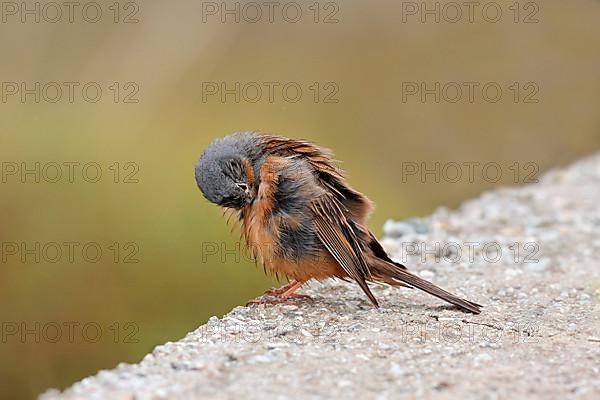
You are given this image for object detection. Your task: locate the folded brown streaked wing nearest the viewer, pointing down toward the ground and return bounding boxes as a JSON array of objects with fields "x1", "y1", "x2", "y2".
[{"x1": 311, "y1": 194, "x2": 379, "y2": 306}]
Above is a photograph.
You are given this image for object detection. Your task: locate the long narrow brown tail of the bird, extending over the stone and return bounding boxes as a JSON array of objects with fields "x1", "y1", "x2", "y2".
[{"x1": 370, "y1": 259, "x2": 483, "y2": 314}]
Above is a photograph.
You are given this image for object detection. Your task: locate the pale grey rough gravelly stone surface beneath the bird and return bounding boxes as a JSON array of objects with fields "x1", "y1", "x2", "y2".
[{"x1": 41, "y1": 155, "x2": 600, "y2": 400}]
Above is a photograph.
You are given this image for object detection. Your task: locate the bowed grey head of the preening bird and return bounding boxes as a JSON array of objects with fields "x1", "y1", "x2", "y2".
[{"x1": 196, "y1": 132, "x2": 260, "y2": 209}]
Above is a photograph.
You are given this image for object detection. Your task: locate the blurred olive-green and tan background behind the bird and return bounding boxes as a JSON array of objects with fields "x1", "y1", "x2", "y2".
[{"x1": 0, "y1": 0, "x2": 600, "y2": 399}]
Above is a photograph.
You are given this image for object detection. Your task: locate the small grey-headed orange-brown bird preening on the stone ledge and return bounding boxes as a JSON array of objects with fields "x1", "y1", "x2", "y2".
[{"x1": 195, "y1": 131, "x2": 482, "y2": 314}]
